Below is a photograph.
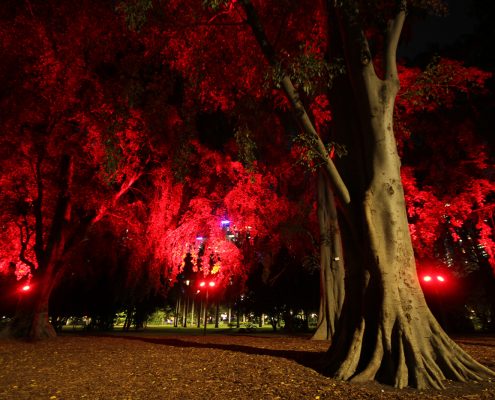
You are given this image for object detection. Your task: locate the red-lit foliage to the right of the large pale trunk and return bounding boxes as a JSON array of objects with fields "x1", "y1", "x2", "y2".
[{"x1": 396, "y1": 59, "x2": 495, "y2": 268}]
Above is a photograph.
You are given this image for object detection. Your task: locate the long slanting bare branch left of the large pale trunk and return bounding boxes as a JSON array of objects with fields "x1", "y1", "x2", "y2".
[{"x1": 240, "y1": 0, "x2": 351, "y2": 204}]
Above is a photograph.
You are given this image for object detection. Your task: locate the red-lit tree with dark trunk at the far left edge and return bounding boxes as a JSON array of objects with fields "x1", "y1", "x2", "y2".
[{"x1": 1, "y1": 3, "x2": 153, "y2": 339}]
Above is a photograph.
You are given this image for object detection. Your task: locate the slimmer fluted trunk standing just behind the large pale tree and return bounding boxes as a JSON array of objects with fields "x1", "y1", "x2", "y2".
[{"x1": 312, "y1": 171, "x2": 344, "y2": 340}]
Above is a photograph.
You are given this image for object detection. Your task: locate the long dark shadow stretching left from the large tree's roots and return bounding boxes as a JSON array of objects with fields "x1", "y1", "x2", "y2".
[{"x1": 107, "y1": 336, "x2": 325, "y2": 374}]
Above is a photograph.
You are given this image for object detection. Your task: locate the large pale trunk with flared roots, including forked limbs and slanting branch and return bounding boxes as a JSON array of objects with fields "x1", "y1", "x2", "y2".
[{"x1": 241, "y1": 0, "x2": 495, "y2": 388}]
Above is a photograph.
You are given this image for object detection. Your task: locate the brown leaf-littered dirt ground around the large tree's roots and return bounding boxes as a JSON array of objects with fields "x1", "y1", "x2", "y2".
[{"x1": 0, "y1": 333, "x2": 495, "y2": 400}]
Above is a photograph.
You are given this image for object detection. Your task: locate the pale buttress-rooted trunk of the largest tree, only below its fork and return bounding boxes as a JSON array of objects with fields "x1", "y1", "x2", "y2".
[{"x1": 327, "y1": 25, "x2": 493, "y2": 388}]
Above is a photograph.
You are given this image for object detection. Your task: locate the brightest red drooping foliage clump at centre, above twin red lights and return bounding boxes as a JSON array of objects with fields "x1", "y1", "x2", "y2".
[{"x1": 146, "y1": 142, "x2": 306, "y2": 286}]
